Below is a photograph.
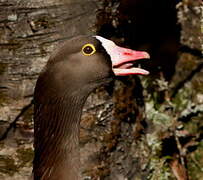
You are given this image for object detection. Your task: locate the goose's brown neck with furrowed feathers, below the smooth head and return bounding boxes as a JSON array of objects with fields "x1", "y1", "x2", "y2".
[{"x1": 33, "y1": 96, "x2": 86, "y2": 180}]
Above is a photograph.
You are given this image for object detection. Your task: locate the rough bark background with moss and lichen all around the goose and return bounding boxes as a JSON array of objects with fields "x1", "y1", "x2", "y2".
[{"x1": 0, "y1": 0, "x2": 203, "y2": 180}]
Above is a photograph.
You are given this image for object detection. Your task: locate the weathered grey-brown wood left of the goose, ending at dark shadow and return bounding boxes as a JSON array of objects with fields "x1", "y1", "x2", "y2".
[{"x1": 0, "y1": 0, "x2": 100, "y2": 179}]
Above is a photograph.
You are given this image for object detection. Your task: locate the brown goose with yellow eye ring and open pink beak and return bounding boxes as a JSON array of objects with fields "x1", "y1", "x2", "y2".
[{"x1": 32, "y1": 36, "x2": 149, "y2": 180}]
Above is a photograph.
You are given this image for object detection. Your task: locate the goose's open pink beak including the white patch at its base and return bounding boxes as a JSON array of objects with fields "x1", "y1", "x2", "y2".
[{"x1": 95, "y1": 36, "x2": 150, "y2": 76}]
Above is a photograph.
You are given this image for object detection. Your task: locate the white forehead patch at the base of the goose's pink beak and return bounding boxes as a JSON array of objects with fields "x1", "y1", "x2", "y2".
[{"x1": 94, "y1": 36, "x2": 116, "y2": 57}]
